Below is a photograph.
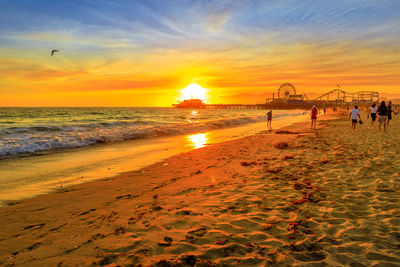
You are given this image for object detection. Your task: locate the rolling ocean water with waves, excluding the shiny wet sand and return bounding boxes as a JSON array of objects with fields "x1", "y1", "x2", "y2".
[{"x1": 0, "y1": 108, "x2": 301, "y2": 159}]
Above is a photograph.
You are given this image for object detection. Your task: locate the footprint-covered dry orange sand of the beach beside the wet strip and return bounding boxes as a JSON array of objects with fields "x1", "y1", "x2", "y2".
[{"x1": 0, "y1": 112, "x2": 400, "y2": 266}]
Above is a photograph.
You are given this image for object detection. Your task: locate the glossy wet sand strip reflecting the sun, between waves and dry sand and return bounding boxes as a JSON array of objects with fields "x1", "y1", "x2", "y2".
[{"x1": 0, "y1": 111, "x2": 310, "y2": 206}]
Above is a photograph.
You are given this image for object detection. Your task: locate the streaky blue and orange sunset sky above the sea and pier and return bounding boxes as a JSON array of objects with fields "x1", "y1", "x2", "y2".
[{"x1": 0, "y1": 0, "x2": 400, "y2": 106}]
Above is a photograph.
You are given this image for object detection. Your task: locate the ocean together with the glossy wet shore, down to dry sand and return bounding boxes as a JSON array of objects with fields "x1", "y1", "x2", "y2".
[{"x1": 0, "y1": 108, "x2": 308, "y2": 206}]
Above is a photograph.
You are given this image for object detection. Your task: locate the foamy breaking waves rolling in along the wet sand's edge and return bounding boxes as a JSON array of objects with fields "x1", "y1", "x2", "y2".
[{"x1": 0, "y1": 113, "x2": 299, "y2": 156}]
